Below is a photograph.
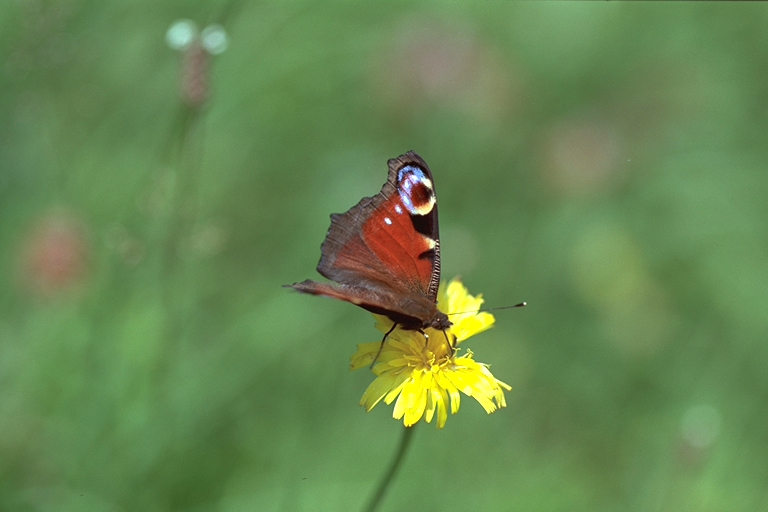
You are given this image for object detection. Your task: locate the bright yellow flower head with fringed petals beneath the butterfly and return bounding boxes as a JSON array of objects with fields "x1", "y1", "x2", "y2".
[{"x1": 351, "y1": 279, "x2": 512, "y2": 428}]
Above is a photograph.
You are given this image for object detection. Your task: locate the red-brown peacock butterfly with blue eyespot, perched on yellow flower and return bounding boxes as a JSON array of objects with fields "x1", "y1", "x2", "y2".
[{"x1": 286, "y1": 151, "x2": 451, "y2": 336}]
